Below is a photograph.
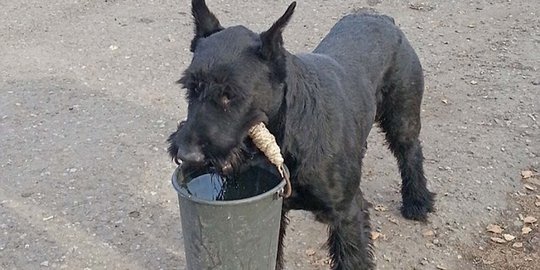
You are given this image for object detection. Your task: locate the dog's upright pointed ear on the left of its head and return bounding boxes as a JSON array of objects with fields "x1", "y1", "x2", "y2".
[{"x1": 191, "y1": 0, "x2": 223, "y2": 52}]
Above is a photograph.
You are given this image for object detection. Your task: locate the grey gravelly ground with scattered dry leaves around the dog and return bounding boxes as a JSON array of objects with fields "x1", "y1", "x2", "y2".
[{"x1": 0, "y1": 0, "x2": 540, "y2": 270}]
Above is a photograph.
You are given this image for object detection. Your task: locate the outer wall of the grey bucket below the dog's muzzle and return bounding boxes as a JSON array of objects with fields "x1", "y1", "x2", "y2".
[{"x1": 172, "y1": 167, "x2": 285, "y2": 270}]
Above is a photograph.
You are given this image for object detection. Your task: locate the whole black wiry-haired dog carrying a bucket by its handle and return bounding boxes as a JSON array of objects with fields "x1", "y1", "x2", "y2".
[{"x1": 169, "y1": 0, "x2": 434, "y2": 269}]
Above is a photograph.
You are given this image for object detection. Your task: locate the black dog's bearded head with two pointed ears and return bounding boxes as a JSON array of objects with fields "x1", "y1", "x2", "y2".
[{"x1": 168, "y1": 0, "x2": 296, "y2": 172}]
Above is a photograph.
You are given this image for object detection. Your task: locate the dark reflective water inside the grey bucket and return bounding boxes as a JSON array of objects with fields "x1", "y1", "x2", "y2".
[{"x1": 180, "y1": 167, "x2": 281, "y2": 201}]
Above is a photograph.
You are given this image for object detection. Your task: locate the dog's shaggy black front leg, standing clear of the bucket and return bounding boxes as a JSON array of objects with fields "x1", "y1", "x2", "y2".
[{"x1": 324, "y1": 191, "x2": 375, "y2": 270}]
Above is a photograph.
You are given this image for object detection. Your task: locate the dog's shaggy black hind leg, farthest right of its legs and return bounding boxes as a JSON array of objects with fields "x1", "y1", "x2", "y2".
[{"x1": 377, "y1": 55, "x2": 435, "y2": 221}]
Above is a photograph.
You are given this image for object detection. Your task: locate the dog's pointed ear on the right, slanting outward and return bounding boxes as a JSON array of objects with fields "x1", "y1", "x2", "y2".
[{"x1": 260, "y1": 2, "x2": 296, "y2": 60}]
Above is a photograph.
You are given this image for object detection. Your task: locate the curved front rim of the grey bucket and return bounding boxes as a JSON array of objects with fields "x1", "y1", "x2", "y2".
[{"x1": 171, "y1": 166, "x2": 286, "y2": 206}]
